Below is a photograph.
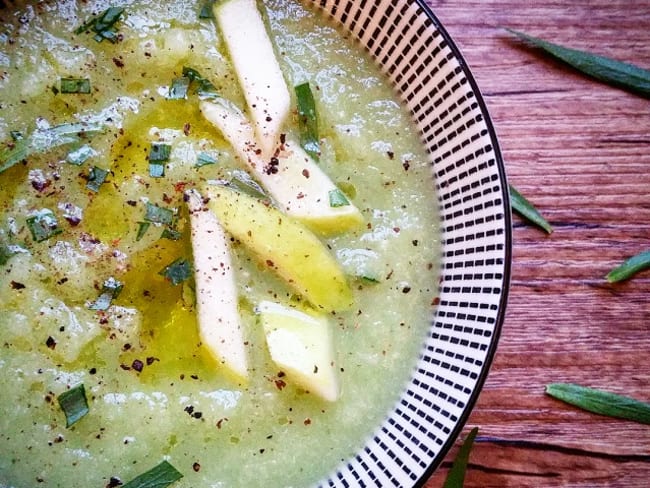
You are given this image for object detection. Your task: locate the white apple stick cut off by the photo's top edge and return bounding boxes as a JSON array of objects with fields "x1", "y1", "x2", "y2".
[{"x1": 213, "y1": 0, "x2": 291, "y2": 157}]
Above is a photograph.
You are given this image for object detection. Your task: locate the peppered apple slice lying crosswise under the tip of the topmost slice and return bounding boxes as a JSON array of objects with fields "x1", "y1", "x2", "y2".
[{"x1": 200, "y1": 99, "x2": 363, "y2": 235}]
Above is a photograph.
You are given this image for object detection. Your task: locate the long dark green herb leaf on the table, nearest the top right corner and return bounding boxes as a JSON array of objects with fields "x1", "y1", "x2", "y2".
[{"x1": 506, "y1": 29, "x2": 650, "y2": 98}]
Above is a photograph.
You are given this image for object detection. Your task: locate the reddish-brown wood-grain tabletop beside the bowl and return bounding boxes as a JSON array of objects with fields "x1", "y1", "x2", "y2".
[{"x1": 426, "y1": 0, "x2": 650, "y2": 488}]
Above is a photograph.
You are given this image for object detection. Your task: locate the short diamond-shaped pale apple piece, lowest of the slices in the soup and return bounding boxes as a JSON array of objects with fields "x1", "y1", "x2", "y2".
[{"x1": 257, "y1": 301, "x2": 340, "y2": 402}]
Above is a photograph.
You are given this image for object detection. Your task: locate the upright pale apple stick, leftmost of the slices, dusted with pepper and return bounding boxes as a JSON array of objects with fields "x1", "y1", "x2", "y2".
[{"x1": 186, "y1": 190, "x2": 248, "y2": 380}]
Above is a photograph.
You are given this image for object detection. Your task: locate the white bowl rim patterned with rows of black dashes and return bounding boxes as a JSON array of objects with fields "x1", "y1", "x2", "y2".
[{"x1": 308, "y1": 0, "x2": 511, "y2": 487}]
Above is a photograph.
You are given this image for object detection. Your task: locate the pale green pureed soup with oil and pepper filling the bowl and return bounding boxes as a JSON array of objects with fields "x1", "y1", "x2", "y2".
[{"x1": 0, "y1": 0, "x2": 439, "y2": 487}]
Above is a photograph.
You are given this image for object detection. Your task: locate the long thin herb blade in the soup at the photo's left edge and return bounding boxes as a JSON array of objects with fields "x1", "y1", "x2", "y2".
[{"x1": 0, "y1": 122, "x2": 103, "y2": 173}]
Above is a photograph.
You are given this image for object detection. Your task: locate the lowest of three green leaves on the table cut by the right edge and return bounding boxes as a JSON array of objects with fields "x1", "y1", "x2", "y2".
[{"x1": 546, "y1": 383, "x2": 650, "y2": 424}]
